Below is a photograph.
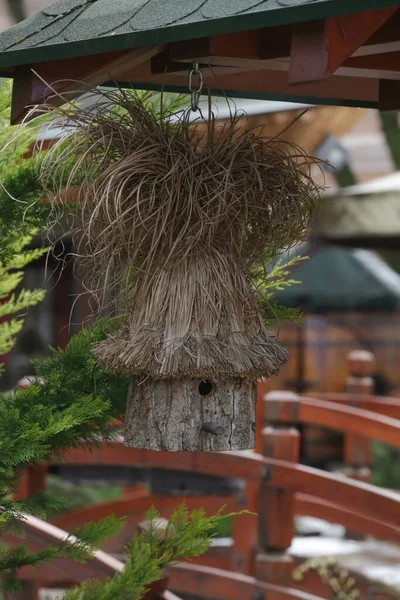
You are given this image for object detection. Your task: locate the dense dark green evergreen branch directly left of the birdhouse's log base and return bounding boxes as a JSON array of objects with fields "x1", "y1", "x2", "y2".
[{"x1": 0, "y1": 322, "x2": 128, "y2": 472}]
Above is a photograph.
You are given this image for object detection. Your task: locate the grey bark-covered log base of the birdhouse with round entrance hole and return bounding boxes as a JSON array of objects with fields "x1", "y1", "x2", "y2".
[{"x1": 124, "y1": 378, "x2": 257, "y2": 452}]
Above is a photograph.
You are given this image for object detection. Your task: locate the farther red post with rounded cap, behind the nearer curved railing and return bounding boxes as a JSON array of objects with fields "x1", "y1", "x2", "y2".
[{"x1": 343, "y1": 350, "x2": 375, "y2": 482}]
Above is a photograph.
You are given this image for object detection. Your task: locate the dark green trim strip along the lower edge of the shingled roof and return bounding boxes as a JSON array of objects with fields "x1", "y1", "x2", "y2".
[{"x1": 0, "y1": 0, "x2": 400, "y2": 69}]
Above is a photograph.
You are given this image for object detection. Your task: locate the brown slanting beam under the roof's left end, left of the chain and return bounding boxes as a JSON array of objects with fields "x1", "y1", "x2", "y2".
[{"x1": 11, "y1": 46, "x2": 164, "y2": 124}]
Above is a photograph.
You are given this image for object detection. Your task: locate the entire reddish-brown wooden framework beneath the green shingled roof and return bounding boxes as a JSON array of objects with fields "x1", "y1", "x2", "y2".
[{"x1": 7, "y1": 7, "x2": 400, "y2": 117}]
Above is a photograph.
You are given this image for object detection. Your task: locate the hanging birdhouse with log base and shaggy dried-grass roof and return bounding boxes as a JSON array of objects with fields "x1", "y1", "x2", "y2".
[{"x1": 35, "y1": 84, "x2": 319, "y2": 451}]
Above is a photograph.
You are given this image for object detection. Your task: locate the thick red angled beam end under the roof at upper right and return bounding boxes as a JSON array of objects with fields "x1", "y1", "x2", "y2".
[{"x1": 289, "y1": 7, "x2": 398, "y2": 85}]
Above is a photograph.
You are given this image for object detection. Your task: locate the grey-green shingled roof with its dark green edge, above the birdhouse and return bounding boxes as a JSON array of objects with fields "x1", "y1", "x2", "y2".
[{"x1": 0, "y1": 0, "x2": 400, "y2": 68}]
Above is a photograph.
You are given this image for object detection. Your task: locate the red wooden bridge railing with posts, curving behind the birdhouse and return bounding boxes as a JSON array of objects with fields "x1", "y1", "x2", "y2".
[{"x1": 9, "y1": 346, "x2": 400, "y2": 600}]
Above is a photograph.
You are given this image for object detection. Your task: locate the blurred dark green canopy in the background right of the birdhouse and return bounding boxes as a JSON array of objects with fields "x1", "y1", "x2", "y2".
[{"x1": 275, "y1": 243, "x2": 400, "y2": 393}]
